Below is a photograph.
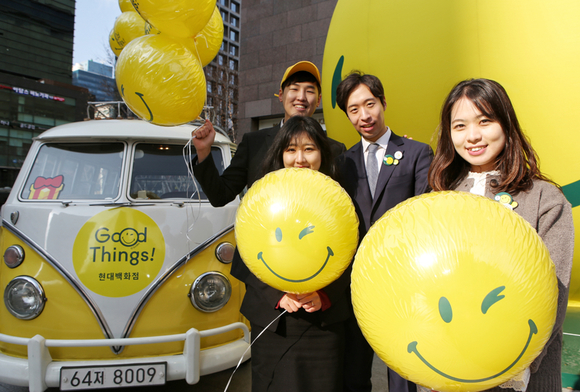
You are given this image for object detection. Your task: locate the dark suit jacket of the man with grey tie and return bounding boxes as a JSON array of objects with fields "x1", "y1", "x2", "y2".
[{"x1": 338, "y1": 133, "x2": 433, "y2": 241}]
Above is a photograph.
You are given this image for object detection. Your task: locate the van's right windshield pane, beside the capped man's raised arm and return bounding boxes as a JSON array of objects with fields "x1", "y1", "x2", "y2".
[{"x1": 129, "y1": 143, "x2": 224, "y2": 200}]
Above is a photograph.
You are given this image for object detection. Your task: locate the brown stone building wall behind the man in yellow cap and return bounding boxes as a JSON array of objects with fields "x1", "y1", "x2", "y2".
[{"x1": 237, "y1": 0, "x2": 338, "y2": 141}]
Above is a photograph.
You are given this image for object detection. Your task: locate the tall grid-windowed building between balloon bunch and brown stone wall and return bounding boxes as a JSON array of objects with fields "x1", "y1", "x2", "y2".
[{"x1": 204, "y1": 0, "x2": 240, "y2": 140}]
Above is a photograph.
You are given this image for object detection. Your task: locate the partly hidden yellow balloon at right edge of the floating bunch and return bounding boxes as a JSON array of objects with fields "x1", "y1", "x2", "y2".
[{"x1": 183, "y1": 7, "x2": 224, "y2": 67}]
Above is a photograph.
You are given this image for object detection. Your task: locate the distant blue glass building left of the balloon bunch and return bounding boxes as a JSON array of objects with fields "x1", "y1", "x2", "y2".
[{"x1": 72, "y1": 60, "x2": 121, "y2": 102}]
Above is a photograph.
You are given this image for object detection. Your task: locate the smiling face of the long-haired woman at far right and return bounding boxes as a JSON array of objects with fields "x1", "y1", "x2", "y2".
[{"x1": 451, "y1": 97, "x2": 506, "y2": 172}]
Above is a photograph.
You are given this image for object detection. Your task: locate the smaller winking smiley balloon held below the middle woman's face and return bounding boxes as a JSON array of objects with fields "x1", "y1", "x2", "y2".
[{"x1": 235, "y1": 168, "x2": 358, "y2": 293}]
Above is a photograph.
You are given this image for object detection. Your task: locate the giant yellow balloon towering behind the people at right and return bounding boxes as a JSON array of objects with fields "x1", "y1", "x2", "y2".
[{"x1": 322, "y1": 0, "x2": 580, "y2": 300}]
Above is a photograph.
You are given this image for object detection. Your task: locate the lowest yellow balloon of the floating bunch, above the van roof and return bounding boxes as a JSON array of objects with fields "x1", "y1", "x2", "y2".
[{"x1": 115, "y1": 34, "x2": 206, "y2": 125}]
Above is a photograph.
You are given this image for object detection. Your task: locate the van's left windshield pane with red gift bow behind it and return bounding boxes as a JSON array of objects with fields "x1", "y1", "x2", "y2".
[{"x1": 21, "y1": 143, "x2": 124, "y2": 200}]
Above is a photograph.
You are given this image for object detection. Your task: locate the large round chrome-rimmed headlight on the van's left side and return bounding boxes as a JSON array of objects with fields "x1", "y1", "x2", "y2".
[{"x1": 4, "y1": 276, "x2": 46, "y2": 320}]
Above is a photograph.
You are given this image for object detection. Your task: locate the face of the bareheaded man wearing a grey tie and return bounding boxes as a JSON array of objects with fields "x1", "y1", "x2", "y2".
[{"x1": 346, "y1": 84, "x2": 387, "y2": 142}]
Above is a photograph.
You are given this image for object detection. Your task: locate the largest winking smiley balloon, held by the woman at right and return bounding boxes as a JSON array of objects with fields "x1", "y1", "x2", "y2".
[{"x1": 351, "y1": 192, "x2": 558, "y2": 391}]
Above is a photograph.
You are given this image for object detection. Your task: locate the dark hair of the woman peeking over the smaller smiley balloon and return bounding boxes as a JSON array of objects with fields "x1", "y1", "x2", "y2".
[{"x1": 262, "y1": 116, "x2": 336, "y2": 179}]
